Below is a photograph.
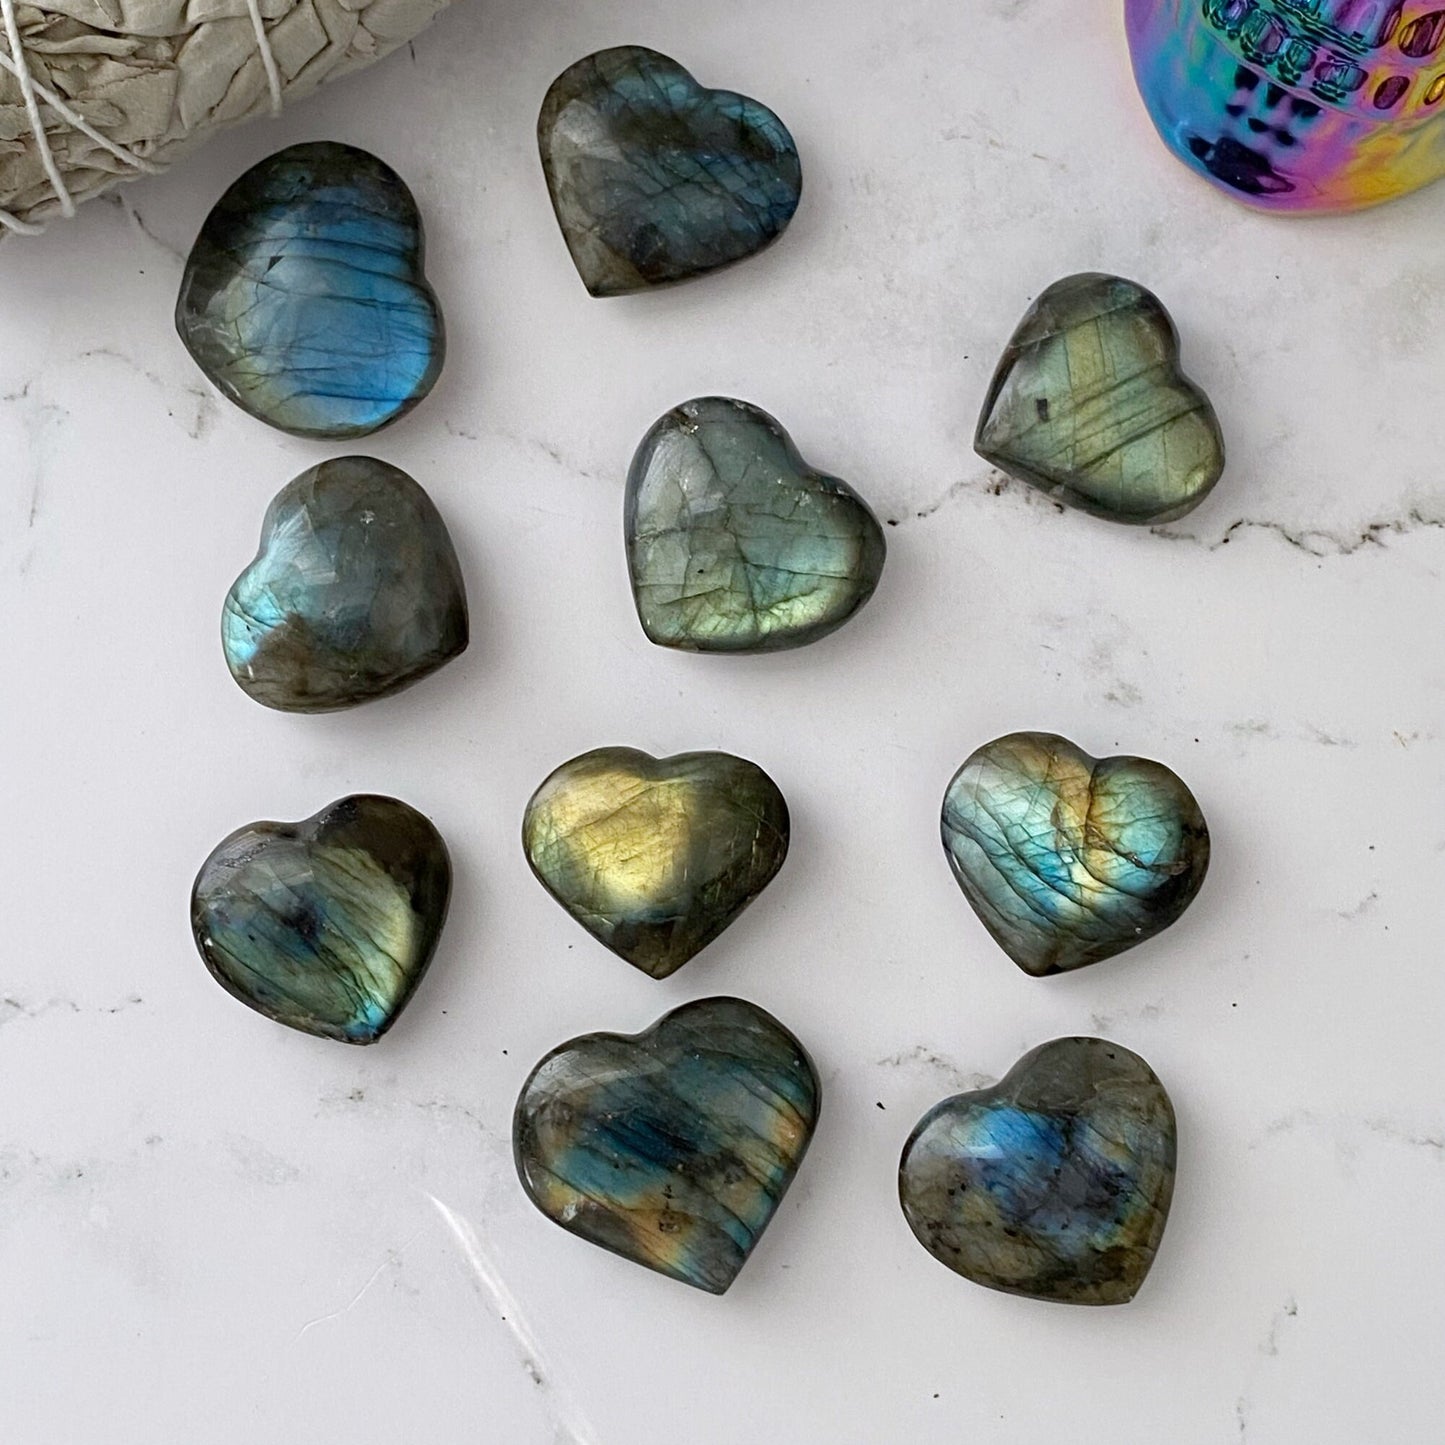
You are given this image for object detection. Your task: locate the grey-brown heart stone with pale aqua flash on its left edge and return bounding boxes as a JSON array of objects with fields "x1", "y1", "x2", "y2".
[{"x1": 221, "y1": 457, "x2": 467, "y2": 712}]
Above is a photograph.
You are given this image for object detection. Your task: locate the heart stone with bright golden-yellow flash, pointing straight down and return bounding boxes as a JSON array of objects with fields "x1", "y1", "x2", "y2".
[{"x1": 522, "y1": 747, "x2": 788, "y2": 978}]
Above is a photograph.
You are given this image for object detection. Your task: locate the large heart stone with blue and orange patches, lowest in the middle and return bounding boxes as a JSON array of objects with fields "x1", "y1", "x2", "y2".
[{"x1": 512, "y1": 998, "x2": 819, "y2": 1295}]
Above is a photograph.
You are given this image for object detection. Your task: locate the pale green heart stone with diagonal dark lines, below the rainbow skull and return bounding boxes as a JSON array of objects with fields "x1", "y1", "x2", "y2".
[{"x1": 974, "y1": 275, "x2": 1224, "y2": 525}]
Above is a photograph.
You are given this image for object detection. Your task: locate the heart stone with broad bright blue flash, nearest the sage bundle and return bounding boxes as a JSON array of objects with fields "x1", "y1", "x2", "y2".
[{"x1": 176, "y1": 142, "x2": 445, "y2": 439}]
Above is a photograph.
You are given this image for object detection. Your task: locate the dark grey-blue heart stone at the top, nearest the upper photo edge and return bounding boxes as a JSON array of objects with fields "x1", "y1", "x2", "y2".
[{"x1": 538, "y1": 45, "x2": 802, "y2": 296}]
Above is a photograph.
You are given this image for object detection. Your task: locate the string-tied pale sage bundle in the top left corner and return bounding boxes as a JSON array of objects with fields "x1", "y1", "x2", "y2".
[{"x1": 0, "y1": 0, "x2": 448, "y2": 236}]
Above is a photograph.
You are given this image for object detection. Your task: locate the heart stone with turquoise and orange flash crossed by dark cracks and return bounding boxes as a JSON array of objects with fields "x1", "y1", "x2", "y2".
[{"x1": 944, "y1": 733, "x2": 1209, "y2": 977}]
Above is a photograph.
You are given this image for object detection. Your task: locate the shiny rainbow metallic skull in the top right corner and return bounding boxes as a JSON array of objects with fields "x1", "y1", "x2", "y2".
[{"x1": 1126, "y1": 0, "x2": 1445, "y2": 211}]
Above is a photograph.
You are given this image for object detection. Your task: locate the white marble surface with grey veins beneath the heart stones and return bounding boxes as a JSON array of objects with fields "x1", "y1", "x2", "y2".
[{"x1": 0, "y1": 0, "x2": 1445, "y2": 1445}]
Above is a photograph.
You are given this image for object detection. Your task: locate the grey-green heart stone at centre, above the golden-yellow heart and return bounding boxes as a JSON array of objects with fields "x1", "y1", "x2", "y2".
[{"x1": 624, "y1": 396, "x2": 886, "y2": 652}]
